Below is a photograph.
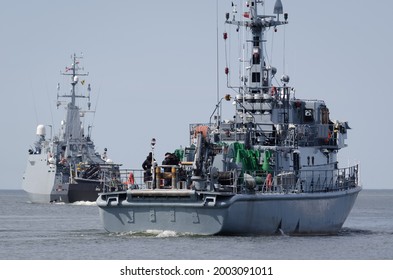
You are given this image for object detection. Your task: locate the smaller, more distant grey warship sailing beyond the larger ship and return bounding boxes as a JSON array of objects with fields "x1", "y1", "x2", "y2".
[{"x1": 22, "y1": 54, "x2": 120, "y2": 203}]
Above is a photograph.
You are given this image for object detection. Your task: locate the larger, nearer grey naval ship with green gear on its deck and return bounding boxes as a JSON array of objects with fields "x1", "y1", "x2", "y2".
[{"x1": 97, "y1": 0, "x2": 362, "y2": 235}]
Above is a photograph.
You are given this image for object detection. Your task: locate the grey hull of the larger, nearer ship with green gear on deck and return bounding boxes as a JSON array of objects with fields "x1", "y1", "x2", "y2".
[{"x1": 97, "y1": 187, "x2": 361, "y2": 235}]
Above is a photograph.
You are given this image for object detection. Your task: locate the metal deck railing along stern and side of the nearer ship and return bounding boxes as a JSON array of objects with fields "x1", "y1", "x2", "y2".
[{"x1": 104, "y1": 163, "x2": 359, "y2": 193}]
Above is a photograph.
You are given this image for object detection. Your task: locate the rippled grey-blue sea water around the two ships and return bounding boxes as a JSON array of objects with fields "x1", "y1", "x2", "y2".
[{"x1": 0, "y1": 190, "x2": 393, "y2": 260}]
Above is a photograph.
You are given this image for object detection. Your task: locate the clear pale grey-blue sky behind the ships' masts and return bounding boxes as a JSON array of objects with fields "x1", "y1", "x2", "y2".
[{"x1": 0, "y1": 0, "x2": 393, "y2": 189}]
